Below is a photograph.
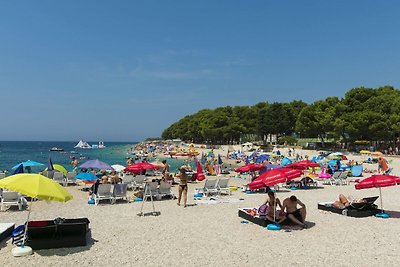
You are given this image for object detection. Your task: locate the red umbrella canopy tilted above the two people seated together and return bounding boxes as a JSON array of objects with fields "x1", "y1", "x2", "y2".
[{"x1": 249, "y1": 168, "x2": 303, "y2": 190}]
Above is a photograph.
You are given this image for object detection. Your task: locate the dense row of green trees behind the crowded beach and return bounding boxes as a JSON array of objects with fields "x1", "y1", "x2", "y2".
[{"x1": 162, "y1": 86, "x2": 400, "y2": 148}]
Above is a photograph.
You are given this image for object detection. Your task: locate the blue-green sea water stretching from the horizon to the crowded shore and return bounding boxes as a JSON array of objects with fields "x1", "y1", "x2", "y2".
[{"x1": 0, "y1": 141, "x2": 192, "y2": 172}]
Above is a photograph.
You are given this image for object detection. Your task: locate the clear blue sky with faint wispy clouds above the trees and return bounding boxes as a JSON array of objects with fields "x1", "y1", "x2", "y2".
[{"x1": 0, "y1": 0, "x2": 400, "y2": 141}]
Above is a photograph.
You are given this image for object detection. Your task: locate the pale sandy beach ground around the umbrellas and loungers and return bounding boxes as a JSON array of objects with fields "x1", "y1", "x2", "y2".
[{"x1": 0, "y1": 150, "x2": 400, "y2": 266}]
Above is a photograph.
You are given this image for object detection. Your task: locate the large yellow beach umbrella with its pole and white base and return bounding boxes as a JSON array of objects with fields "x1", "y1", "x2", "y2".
[{"x1": 0, "y1": 173, "x2": 72, "y2": 255}]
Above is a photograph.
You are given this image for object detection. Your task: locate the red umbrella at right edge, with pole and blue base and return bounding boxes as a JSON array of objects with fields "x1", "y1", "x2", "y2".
[{"x1": 355, "y1": 175, "x2": 400, "y2": 218}]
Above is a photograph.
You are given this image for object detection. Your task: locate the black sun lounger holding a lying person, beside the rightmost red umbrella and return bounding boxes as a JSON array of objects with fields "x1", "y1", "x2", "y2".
[{"x1": 318, "y1": 196, "x2": 380, "y2": 218}]
